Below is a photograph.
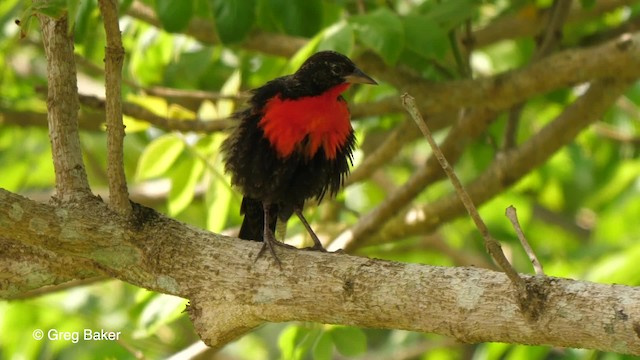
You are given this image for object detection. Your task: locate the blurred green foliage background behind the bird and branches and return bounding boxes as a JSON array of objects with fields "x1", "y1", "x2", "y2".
[{"x1": 0, "y1": 0, "x2": 640, "y2": 359}]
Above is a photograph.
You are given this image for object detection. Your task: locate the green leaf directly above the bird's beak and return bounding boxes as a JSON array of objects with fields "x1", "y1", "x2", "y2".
[{"x1": 349, "y1": 8, "x2": 404, "y2": 65}]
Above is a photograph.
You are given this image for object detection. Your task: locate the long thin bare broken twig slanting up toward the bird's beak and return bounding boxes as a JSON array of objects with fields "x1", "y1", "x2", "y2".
[{"x1": 402, "y1": 93, "x2": 527, "y2": 298}]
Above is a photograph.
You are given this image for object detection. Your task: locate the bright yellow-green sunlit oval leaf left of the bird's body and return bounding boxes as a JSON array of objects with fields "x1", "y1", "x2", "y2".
[{"x1": 135, "y1": 134, "x2": 184, "y2": 181}]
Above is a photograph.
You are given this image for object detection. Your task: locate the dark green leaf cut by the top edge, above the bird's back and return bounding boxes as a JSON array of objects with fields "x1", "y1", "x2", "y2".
[{"x1": 211, "y1": 0, "x2": 256, "y2": 44}]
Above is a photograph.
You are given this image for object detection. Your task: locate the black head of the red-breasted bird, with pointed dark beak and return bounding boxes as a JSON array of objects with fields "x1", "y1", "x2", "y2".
[{"x1": 294, "y1": 51, "x2": 378, "y2": 91}]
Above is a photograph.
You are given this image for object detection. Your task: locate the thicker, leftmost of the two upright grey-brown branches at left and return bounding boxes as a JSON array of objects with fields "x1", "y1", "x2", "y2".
[{"x1": 38, "y1": 11, "x2": 91, "y2": 202}]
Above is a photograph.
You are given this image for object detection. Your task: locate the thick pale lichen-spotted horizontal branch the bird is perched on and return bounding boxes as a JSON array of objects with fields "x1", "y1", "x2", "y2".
[{"x1": 0, "y1": 190, "x2": 640, "y2": 354}]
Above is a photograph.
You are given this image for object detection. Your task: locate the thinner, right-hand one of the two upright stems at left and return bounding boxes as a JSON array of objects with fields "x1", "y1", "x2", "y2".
[{"x1": 98, "y1": 0, "x2": 132, "y2": 216}]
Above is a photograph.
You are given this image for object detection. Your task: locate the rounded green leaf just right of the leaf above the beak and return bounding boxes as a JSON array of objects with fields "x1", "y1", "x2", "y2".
[{"x1": 402, "y1": 15, "x2": 449, "y2": 59}]
